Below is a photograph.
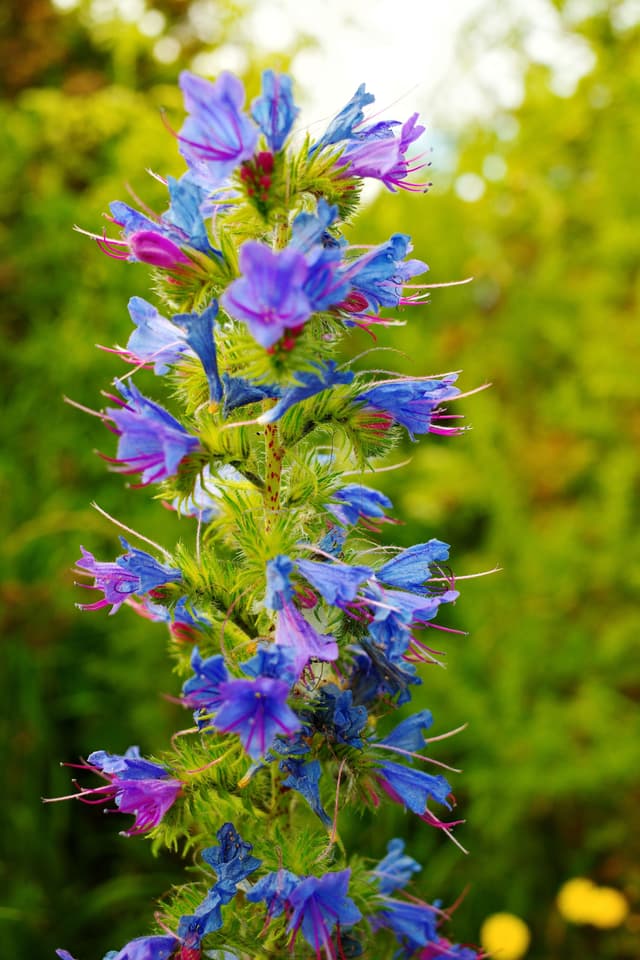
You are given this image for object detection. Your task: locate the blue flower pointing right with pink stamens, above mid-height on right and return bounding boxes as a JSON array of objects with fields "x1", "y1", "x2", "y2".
[{"x1": 357, "y1": 374, "x2": 460, "y2": 440}]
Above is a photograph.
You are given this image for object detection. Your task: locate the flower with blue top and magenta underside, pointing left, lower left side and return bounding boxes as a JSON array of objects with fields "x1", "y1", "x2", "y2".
[{"x1": 46, "y1": 747, "x2": 183, "y2": 837}]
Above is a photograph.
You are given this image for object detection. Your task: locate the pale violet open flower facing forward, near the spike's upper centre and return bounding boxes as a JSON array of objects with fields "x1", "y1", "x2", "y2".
[{"x1": 220, "y1": 240, "x2": 312, "y2": 348}]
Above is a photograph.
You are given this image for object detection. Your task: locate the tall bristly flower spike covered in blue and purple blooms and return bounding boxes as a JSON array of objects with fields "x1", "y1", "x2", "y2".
[{"x1": 58, "y1": 70, "x2": 480, "y2": 960}]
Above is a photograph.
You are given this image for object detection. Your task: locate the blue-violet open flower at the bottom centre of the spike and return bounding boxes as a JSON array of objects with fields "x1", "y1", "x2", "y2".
[{"x1": 287, "y1": 870, "x2": 362, "y2": 957}]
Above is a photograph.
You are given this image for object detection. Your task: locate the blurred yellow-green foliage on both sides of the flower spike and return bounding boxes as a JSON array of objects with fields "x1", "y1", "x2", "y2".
[{"x1": 0, "y1": 1, "x2": 640, "y2": 960}]
